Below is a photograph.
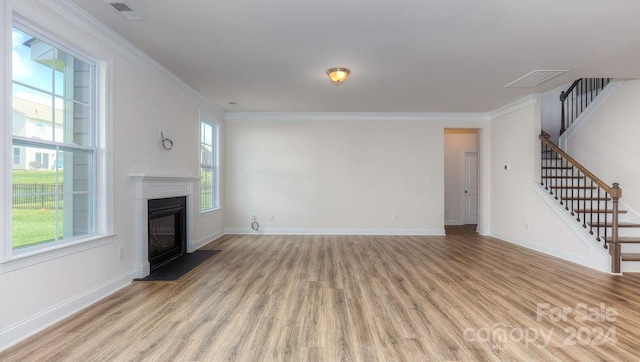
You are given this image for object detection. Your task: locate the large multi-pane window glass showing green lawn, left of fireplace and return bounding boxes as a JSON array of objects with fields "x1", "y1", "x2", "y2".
[{"x1": 11, "y1": 25, "x2": 97, "y2": 251}]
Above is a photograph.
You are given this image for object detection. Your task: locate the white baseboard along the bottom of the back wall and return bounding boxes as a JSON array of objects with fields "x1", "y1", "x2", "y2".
[{"x1": 226, "y1": 228, "x2": 445, "y2": 236}]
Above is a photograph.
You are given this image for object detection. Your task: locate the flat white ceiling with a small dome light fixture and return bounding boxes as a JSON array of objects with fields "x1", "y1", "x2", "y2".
[{"x1": 72, "y1": 0, "x2": 640, "y2": 113}]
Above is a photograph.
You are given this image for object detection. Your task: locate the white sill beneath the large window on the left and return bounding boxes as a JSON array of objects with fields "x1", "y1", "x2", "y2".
[{"x1": 0, "y1": 234, "x2": 116, "y2": 274}]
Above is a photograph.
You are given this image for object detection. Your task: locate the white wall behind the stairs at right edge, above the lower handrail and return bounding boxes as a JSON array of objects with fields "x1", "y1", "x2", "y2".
[{"x1": 566, "y1": 80, "x2": 640, "y2": 215}]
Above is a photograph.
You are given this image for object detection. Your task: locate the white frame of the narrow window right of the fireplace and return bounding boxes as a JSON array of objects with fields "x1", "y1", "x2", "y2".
[{"x1": 198, "y1": 116, "x2": 220, "y2": 214}]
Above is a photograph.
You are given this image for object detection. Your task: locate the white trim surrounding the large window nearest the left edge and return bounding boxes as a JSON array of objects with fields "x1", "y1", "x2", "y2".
[{"x1": 0, "y1": 10, "x2": 116, "y2": 274}]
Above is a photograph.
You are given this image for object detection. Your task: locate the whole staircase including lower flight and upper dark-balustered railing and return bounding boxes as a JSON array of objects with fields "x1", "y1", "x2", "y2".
[{"x1": 539, "y1": 78, "x2": 640, "y2": 273}]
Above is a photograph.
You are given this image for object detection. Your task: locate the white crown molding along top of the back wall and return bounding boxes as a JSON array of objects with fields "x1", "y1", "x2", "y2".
[{"x1": 225, "y1": 112, "x2": 489, "y2": 122}]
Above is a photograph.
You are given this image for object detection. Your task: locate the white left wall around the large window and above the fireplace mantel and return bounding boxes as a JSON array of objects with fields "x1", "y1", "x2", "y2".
[{"x1": 0, "y1": 0, "x2": 224, "y2": 349}]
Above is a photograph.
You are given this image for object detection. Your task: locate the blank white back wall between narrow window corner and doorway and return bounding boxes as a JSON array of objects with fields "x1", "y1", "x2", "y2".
[{"x1": 225, "y1": 120, "x2": 456, "y2": 234}]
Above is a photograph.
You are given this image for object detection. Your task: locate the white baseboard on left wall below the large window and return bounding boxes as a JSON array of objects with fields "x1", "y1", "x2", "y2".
[{"x1": 0, "y1": 272, "x2": 134, "y2": 351}]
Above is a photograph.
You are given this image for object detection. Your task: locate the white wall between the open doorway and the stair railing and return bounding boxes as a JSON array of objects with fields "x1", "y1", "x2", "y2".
[{"x1": 490, "y1": 98, "x2": 607, "y2": 271}]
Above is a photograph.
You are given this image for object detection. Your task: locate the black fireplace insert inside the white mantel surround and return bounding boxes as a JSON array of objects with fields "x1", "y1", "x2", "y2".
[{"x1": 147, "y1": 196, "x2": 187, "y2": 270}]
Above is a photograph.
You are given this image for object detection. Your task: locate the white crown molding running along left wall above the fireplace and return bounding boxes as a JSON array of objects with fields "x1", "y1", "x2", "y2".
[{"x1": 23, "y1": 0, "x2": 224, "y2": 120}]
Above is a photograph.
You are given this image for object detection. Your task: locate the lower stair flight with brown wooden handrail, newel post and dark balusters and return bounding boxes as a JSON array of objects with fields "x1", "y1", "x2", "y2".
[{"x1": 539, "y1": 131, "x2": 640, "y2": 274}]
